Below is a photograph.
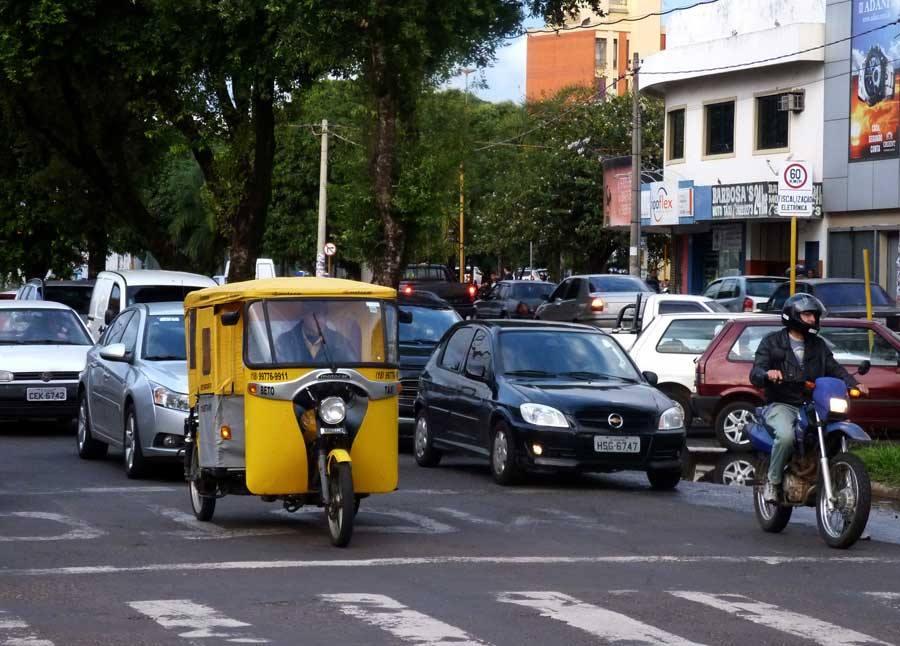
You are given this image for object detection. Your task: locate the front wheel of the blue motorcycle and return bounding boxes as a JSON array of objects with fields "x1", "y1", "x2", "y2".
[{"x1": 816, "y1": 453, "x2": 872, "y2": 549}]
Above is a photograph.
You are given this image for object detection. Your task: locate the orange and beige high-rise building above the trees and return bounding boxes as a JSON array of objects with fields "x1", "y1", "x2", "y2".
[{"x1": 525, "y1": 0, "x2": 666, "y2": 101}]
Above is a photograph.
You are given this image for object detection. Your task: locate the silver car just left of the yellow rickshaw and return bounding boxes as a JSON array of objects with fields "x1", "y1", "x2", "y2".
[{"x1": 77, "y1": 302, "x2": 188, "y2": 478}]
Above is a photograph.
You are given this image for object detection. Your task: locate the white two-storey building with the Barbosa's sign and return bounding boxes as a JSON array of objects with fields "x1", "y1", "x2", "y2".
[{"x1": 640, "y1": 0, "x2": 826, "y2": 292}]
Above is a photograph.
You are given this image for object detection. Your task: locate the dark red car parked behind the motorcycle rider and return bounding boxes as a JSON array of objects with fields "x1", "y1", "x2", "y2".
[{"x1": 691, "y1": 316, "x2": 900, "y2": 451}]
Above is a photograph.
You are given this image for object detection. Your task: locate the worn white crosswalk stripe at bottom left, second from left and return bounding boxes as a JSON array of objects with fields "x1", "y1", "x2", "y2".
[{"x1": 128, "y1": 599, "x2": 269, "y2": 644}]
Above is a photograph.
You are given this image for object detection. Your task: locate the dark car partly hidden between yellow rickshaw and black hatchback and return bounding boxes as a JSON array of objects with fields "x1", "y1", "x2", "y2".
[{"x1": 397, "y1": 292, "x2": 462, "y2": 440}]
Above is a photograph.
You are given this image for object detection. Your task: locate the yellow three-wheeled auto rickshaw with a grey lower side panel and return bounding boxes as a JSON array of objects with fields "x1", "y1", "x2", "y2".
[{"x1": 184, "y1": 278, "x2": 399, "y2": 547}]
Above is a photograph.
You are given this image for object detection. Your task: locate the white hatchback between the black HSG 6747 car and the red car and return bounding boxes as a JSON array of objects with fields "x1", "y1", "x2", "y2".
[{"x1": 613, "y1": 312, "x2": 739, "y2": 426}]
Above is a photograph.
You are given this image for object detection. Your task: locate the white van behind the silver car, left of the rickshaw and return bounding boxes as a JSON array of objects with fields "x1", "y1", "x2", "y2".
[{"x1": 87, "y1": 269, "x2": 216, "y2": 340}]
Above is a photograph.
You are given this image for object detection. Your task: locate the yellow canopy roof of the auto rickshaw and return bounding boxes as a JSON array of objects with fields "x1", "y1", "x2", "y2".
[{"x1": 184, "y1": 276, "x2": 397, "y2": 309}]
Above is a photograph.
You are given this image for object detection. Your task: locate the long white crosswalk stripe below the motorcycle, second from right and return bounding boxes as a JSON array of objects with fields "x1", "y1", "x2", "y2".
[{"x1": 669, "y1": 591, "x2": 890, "y2": 646}]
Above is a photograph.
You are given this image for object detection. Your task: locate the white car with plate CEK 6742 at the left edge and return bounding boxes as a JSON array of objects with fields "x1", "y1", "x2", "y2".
[{"x1": 0, "y1": 300, "x2": 93, "y2": 422}]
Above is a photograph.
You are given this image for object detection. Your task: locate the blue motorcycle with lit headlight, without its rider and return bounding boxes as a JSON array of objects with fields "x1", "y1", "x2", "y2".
[{"x1": 749, "y1": 361, "x2": 872, "y2": 549}]
